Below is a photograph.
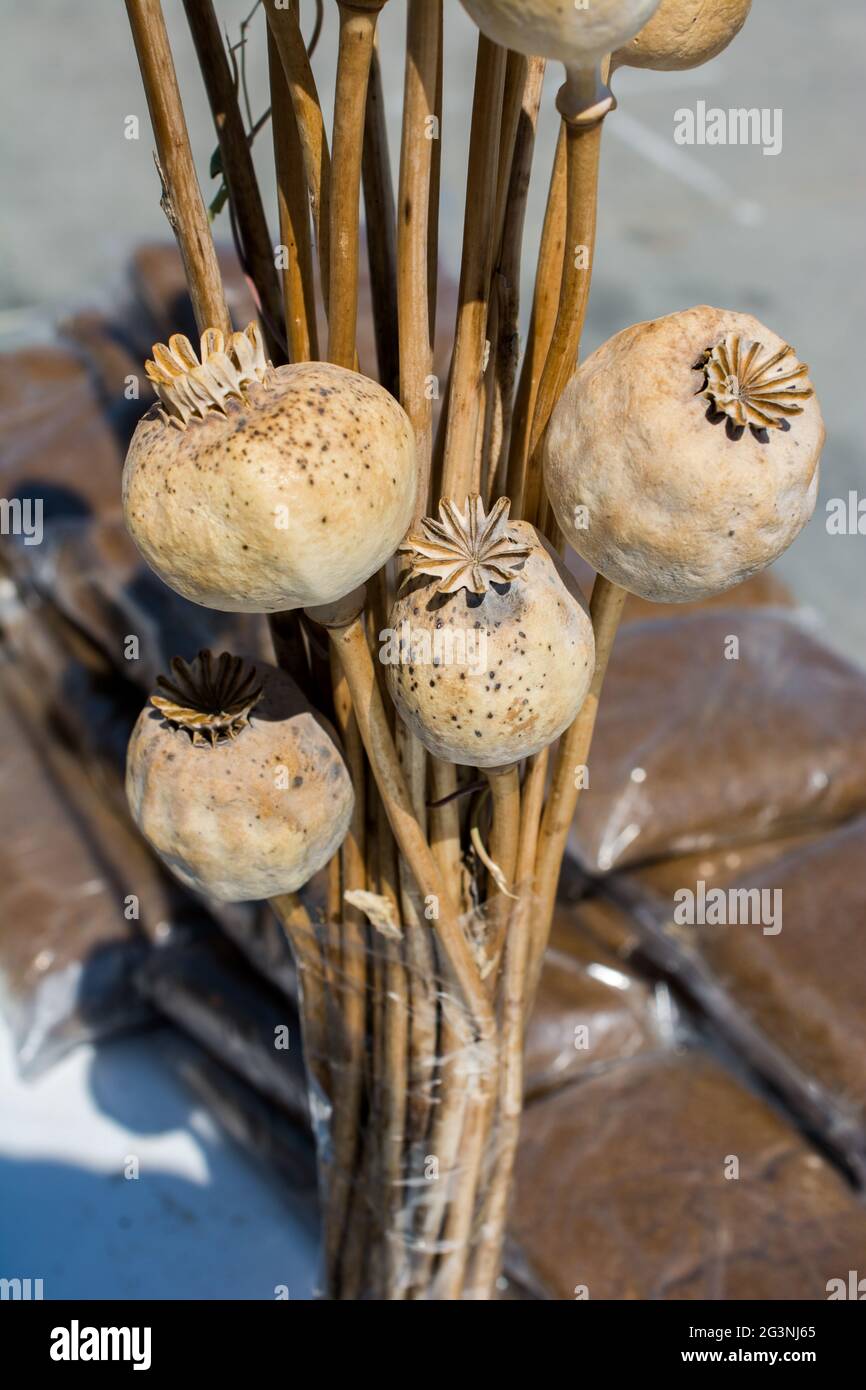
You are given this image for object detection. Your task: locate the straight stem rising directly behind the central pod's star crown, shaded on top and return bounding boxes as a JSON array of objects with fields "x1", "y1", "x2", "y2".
[{"x1": 442, "y1": 35, "x2": 507, "y2": 506}]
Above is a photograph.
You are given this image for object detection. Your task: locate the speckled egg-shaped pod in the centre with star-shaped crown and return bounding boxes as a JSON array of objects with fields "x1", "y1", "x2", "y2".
[{"x1": 389, "y1": 496, "x2": 595, "y2": 767}]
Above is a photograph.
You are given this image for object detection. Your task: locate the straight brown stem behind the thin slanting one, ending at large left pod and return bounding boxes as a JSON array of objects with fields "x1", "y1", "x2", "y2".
[{"x1": 268, "y1": 28, "x2": 318, "y2": 361}]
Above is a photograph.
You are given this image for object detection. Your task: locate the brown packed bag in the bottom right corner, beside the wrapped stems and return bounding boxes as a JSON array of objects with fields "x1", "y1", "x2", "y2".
[{"x1": 510, "y1": 1052, "x2": 866, "y2": 1300}]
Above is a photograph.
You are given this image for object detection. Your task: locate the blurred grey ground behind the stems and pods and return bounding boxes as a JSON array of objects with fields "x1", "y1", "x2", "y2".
[{"x1": 0, "y1": 0, "x2": 866, "y2": 660}]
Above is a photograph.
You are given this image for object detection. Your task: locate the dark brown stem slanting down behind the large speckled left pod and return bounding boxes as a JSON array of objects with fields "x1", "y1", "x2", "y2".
[{"x1": 183, "y1": 0, "x2": 285, "y2": 363}]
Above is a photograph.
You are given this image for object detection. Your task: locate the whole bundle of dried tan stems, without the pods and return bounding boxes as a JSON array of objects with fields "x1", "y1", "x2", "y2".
[{"x1": 126, "y1": 0, "x2": 624, "y2": 1298}]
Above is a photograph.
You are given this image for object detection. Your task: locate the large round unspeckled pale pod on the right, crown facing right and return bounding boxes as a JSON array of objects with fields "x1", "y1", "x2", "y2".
[{"x1": 545, "y1": 306, "x2": 824, "y2": 603}]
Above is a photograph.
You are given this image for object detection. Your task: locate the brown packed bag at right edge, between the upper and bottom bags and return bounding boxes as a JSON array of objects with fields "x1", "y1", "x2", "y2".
[{"x1": 571, "y1": 819, "x2": 866, "y2": 1183}]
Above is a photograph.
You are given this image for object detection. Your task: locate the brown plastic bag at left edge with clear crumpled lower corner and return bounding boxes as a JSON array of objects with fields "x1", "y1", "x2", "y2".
[{"x1": 0, "y1": 701, "x2": 155, "y2": 1076}]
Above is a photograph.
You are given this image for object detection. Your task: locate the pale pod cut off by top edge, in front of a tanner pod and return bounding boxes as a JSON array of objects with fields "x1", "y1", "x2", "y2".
[{"x1": 461, "y1": 0, "x2": 659, "y2": 68}]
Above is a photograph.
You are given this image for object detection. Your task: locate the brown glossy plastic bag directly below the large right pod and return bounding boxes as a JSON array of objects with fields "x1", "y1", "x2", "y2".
[{"x1": 571, "y1": 609, "x2": 866, "y2": 873}]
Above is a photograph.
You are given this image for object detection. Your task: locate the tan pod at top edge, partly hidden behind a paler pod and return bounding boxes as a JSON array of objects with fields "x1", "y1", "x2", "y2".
[{"x1": 612, "y1": 0, "x2": 752, "y2": 72}]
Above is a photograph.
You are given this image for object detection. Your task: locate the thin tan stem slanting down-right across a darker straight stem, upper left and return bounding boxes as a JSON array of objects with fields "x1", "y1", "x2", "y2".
[{"x1": 264, "y1": 0, "x2": 331, "y2": 304}]
